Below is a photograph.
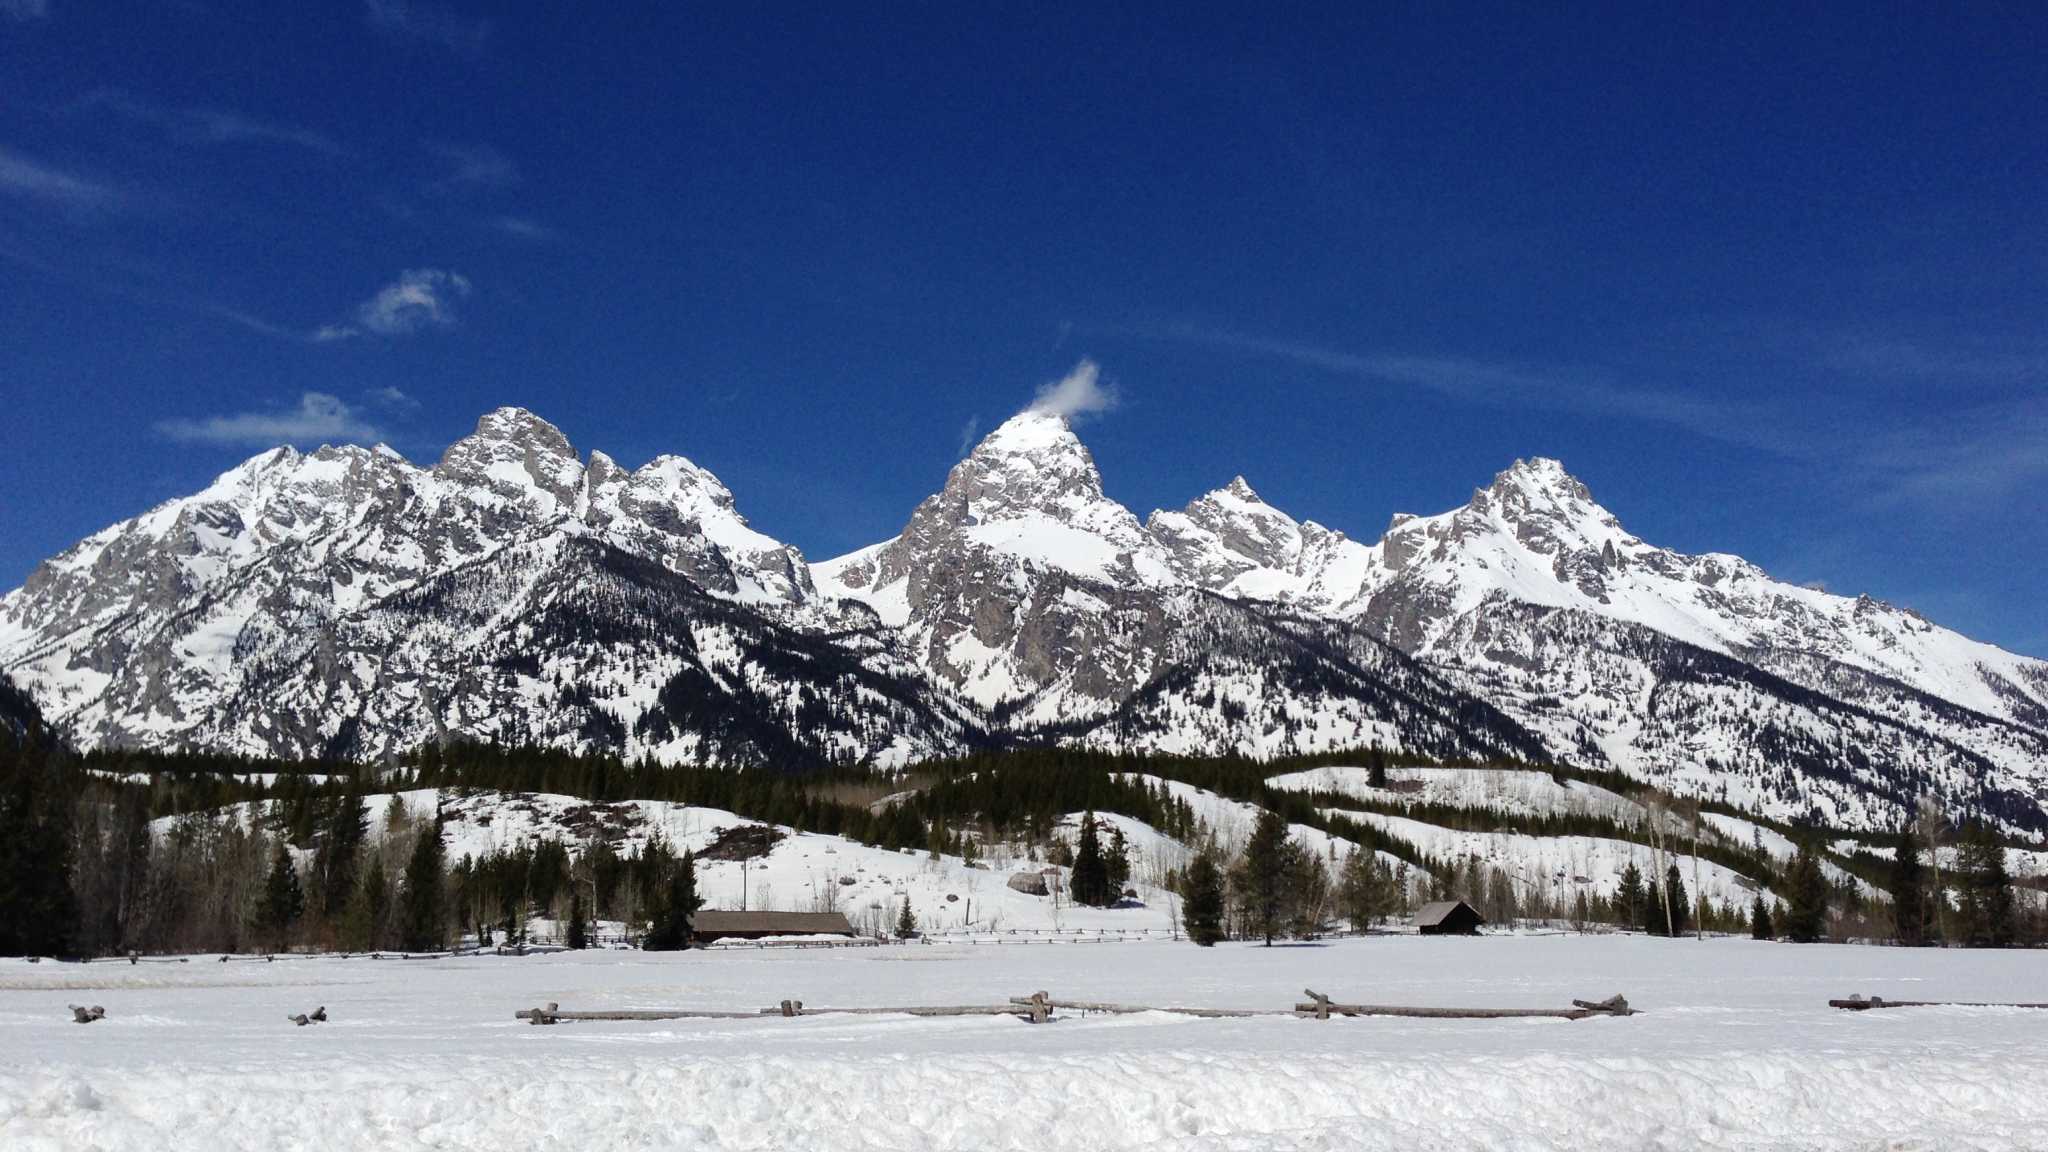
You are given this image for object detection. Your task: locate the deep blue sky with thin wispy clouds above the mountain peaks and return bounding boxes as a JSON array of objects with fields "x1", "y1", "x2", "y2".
[{"x1": 0, "y1": 0, "x2": 2048, "y2": 656}]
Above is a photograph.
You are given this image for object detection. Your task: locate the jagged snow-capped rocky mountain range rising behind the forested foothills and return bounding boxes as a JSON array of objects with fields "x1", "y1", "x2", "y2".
[{"x1": 0, "y1": 408, "x2": 2048, "y2": 830}]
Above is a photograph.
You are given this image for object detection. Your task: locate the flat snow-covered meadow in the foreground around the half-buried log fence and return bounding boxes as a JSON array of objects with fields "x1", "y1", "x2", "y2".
[{"x1": 0, "y1": 935, "x2": 2048, "y2": 1152}]
